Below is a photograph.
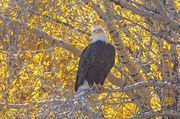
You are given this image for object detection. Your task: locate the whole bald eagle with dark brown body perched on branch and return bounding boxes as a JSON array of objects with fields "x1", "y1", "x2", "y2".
[{"x1": 75, "y1": 26, "x2": 115, "y2": 92}]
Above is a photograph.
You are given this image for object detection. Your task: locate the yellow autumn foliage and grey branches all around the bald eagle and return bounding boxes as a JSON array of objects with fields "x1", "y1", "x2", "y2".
[{"x1": 0, "y1": 0, "x2": 180, "y2": 119}]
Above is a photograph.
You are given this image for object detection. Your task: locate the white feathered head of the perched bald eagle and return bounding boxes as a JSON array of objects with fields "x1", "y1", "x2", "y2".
[{"x1": 92, "y1": 26, "x2": 108, "y2": 43}]
